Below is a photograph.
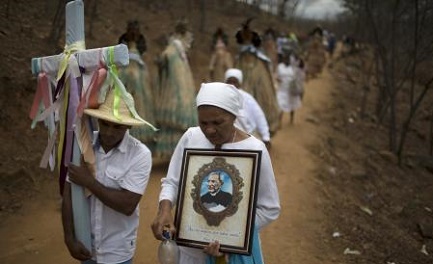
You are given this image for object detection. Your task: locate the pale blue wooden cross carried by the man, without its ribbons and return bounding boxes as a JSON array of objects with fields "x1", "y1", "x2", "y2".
[{"x1": 32, "y1": 0, "x2": 129, "y2": 250}]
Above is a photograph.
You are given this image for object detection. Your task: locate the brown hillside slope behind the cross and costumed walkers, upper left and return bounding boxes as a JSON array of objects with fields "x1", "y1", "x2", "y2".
[{"x1": 0, "y1": 0, "x2": 286, "y2": 210}]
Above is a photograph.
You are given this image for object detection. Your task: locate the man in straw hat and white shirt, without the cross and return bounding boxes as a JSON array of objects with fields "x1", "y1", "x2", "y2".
[{"x1": 62, "y1": 87, "x2": 152, "y2": 264}]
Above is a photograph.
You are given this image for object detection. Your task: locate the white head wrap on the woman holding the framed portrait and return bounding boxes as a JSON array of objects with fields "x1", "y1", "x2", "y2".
[{"x1": 196, "y1": 82, "x2": 243, "y2": 116}]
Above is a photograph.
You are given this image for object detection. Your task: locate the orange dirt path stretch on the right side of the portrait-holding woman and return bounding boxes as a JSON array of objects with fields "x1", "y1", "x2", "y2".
[{"x1": 262, "y1": 66, "x2": 332, "y2": 264}]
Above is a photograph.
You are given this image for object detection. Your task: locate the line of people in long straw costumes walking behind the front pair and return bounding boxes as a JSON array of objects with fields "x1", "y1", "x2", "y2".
[{"x1": 115, "y1": 19, "x2": 328, "y2": 160}]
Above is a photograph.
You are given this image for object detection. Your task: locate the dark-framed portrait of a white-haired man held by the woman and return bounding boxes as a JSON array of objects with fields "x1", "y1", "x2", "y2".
[{"x1": 175, "y1": 149, "x2": 262, "y2": 255}]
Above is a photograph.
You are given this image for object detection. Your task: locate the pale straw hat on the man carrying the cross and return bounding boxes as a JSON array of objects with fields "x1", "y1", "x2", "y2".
[{"x1": 84, "y1": 89, "x2": 146, "y2": 126}]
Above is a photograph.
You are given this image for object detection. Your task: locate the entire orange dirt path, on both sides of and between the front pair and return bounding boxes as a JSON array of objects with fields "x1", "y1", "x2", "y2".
[{"x1": 0, "y1": 66, "x2": 332, "y2": 264}]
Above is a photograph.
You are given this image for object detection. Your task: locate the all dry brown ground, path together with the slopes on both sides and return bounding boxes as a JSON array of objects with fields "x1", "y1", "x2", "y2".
[{"x1": 0, "y1": 0, "x2": 433, "y2": 264}]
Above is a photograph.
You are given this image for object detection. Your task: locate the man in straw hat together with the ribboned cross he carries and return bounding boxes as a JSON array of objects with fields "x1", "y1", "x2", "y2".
[{"x1": 30, "y1": 0, "x2": 155, "y2": 264}]
